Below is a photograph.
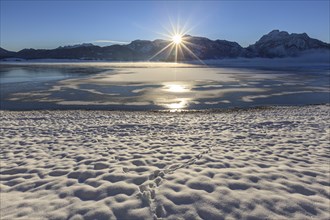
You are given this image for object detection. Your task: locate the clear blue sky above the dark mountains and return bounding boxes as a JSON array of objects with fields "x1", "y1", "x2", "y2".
[{"x1": 0, "y1": 0, "x2": 330, "y2": 51}]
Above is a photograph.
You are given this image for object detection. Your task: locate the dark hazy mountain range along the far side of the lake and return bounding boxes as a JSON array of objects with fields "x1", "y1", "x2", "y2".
[{"x1": 0, "y1": 30, "x2": 330, "y2": 61}]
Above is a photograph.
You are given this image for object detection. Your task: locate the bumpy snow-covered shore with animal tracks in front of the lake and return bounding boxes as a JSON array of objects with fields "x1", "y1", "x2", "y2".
[{"x1": 0, "y1": 105, "x2": 330, "y2": 219}]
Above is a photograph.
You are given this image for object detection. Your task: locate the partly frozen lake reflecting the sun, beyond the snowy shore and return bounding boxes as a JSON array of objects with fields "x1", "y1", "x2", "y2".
[{"x1": 0, "y1": 62, "x2": 330, "y2": 110}]
